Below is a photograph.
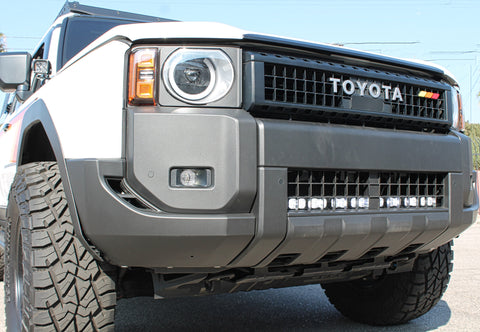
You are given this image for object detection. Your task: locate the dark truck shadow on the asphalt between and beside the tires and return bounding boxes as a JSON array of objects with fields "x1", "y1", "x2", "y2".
[{"x1": 115, "y1": 285, "x2": 451, "y2": 332}]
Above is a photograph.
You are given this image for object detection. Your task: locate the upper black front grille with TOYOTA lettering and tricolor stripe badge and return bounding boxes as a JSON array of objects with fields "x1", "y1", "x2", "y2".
[{"x1": 246, "y1": 53, "x2": 449, "y2": 131}]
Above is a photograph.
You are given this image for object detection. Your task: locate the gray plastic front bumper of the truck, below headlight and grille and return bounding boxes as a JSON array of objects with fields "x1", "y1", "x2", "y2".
[{"x1": 63, "y1": 110, "x2": 478, "y2": 272}]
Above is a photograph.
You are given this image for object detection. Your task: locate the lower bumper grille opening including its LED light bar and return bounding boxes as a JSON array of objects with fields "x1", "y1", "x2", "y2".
[{"x1": 288, "y1": 169, "x2": 447, "y2": 212}]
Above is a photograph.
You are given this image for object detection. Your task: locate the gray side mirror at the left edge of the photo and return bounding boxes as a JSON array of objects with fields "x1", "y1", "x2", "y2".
[{"x1": 0, "y1": 52, "x2": 32, "y2": 92}]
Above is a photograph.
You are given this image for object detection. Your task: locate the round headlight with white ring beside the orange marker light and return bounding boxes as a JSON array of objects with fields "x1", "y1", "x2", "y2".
[{"x1": 162, "y1": 49, "x2": 235, "y2": 104}]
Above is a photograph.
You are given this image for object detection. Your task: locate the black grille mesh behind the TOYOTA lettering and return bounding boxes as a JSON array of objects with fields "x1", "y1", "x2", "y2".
[{"x1": 264, "y1": 63, "x2": 446, "y2": 120}]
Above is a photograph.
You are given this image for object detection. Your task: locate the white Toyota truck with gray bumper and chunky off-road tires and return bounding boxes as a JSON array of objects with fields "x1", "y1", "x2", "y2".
[{"x1": 0, "y1": 2, "x2": 478, "y2": 331}]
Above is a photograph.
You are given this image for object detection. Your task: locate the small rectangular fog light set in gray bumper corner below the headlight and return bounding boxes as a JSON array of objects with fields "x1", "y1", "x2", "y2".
[{"x1": 170, "y1": 168, "x2": 212, "y2": 188}]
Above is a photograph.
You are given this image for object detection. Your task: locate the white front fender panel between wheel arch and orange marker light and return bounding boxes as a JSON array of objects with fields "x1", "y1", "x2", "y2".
[{"x1": 36, "y1": 41, "x2": 128, "y2": 159}]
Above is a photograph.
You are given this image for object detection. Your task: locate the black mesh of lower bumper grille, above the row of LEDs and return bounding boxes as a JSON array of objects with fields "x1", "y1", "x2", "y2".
[{"x1": 288, "y1": 169, "x2": 447, "y2": 209}]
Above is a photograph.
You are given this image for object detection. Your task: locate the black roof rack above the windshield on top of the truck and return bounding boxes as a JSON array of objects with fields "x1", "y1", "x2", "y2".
[{"x1": 57, "y1": 0, "x2": 175, "y2": 22}]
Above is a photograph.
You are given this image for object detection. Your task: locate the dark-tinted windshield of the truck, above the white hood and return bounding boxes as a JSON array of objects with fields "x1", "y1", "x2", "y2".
[{"x1": 62, "y1": 16, "x2": 139, "y2": 66}]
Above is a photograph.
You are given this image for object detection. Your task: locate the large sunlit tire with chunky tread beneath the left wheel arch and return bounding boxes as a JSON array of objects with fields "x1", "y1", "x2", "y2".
[{"x1": 5, "y1": 162, "x2": 116, "y2": 331}]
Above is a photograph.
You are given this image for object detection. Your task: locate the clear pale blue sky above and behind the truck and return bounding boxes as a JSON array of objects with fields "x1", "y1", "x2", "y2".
[{"x1": 0, "y1": 0, "x2": 480, "y2": 123}]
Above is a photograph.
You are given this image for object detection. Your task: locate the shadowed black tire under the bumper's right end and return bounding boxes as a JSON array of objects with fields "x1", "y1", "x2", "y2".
[{"x1": 322, "y1": 243, "x2": 453, "y2": 325}]
